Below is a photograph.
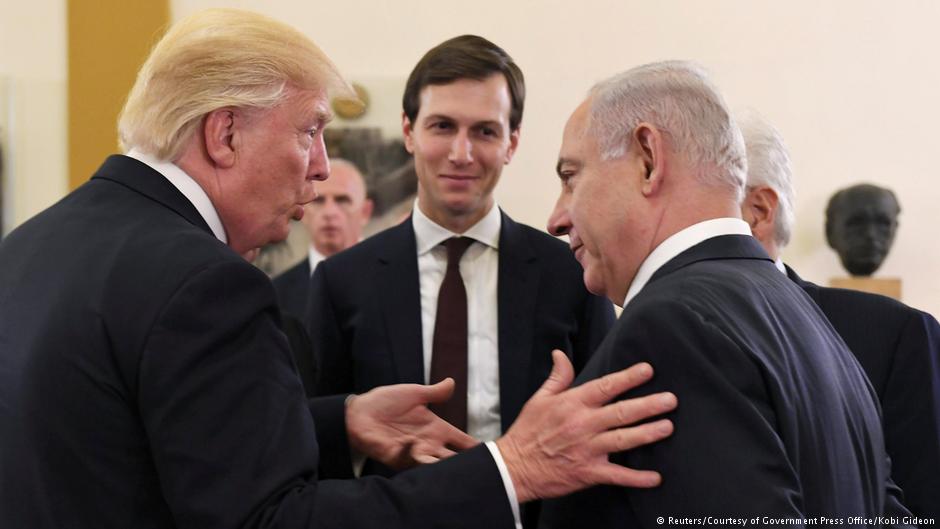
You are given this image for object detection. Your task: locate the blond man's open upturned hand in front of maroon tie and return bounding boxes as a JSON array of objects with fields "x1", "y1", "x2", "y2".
[{"x1": 346, "y1": 378, "x2": 478, "y2": 470}]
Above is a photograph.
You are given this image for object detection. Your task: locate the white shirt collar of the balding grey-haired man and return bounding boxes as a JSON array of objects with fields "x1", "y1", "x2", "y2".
[{"x1": 623, "y1": 218, "x2": 751, "y2": 307}]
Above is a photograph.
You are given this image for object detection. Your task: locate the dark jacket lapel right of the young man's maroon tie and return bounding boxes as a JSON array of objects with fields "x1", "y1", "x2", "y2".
[{"x1": 496, "y1": 212, "x2": 540, "y2": 432}]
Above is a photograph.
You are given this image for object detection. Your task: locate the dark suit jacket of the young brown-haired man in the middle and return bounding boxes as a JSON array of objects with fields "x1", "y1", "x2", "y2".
[{"x1": 307, "y1": 214, "x2": 614, "y2": 431}]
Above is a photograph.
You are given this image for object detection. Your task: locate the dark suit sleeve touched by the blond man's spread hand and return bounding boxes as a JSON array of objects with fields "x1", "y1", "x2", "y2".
[{"x1": 541, "y1": 303, "x2": 803, "y2": 528}]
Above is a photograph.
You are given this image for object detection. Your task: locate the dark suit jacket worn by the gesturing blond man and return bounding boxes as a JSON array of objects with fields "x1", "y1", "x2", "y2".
[{"x1": 0, "y1": 156, "x2": 512, "y2": 529}]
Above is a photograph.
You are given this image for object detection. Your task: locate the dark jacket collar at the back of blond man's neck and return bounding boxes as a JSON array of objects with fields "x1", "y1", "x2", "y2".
[{"x1": 92, "y1": 155, "x2": 214, "y2": 237}]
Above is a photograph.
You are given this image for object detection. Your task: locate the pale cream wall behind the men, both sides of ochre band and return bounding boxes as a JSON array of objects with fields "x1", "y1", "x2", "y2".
[{"x1": 7, "y1": 0, "x2": 940, "y2": 314}]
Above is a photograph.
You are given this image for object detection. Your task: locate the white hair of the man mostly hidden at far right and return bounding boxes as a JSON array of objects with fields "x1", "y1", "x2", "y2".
[{"x1": 738, "y1": 111, "x2": 796, "y2": 247}]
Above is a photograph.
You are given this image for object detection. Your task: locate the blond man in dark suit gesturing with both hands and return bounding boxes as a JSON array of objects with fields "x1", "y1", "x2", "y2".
[{"x1": 0, "y1": 10, "x2": 675, "y2": 529}]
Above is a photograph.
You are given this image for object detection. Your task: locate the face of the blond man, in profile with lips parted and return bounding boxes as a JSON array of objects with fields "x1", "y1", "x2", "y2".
[{"x1": 215, "y1": 89, "x2": 330, "y2": 252}]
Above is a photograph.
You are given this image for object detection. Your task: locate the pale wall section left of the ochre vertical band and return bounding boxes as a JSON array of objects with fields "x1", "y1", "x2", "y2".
[{"x1": 0, "y1": 0, "x2": 67, "y2": 232}]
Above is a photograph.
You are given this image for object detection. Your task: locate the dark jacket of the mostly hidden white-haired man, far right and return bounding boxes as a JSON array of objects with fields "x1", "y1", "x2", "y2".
[{"x1": 787, "y1": 267, "x2": 940, "y2": 521}]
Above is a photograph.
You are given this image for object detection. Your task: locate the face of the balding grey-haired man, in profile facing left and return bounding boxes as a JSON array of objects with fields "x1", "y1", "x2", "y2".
[{"x1": 548, "y1": 101, "x2": 649, "y2": 304}]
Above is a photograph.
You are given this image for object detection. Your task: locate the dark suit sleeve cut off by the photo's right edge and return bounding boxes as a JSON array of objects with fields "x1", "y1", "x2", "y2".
[{"x1": 882, "y1": 311, "x2": 940, "y2": 520}]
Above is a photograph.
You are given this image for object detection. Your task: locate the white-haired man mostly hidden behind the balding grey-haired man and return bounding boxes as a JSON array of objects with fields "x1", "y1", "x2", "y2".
[{"x1": 739, "y1": 112, "x2": 940, "y2": 520}]
